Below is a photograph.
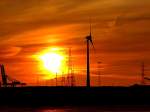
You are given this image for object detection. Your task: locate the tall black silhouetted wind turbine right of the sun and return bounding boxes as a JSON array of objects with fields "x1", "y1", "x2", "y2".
[{"x1": 86, "y1": 21, "x2": 94, "y2": 87}]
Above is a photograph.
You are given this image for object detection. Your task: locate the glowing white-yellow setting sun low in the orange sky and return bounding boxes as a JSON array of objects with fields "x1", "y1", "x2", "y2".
[{"x1": 34, "y1": 48, "x2": 67, "y2": 79}]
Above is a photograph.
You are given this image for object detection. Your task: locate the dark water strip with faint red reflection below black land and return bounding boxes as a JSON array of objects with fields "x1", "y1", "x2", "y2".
[{"x1": 0, "y1": 105, "x2": 150, "y2": 112}]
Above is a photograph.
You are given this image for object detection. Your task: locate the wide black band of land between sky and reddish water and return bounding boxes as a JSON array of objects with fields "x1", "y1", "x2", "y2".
[{"x1": 0, "y1": 86, "x2": 150, "y2": 106}]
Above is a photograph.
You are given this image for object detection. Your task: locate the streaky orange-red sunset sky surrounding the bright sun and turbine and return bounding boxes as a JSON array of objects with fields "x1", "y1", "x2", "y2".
[{"x1": 0, "y1": 0, "x2": 150, "y2": 86}]
